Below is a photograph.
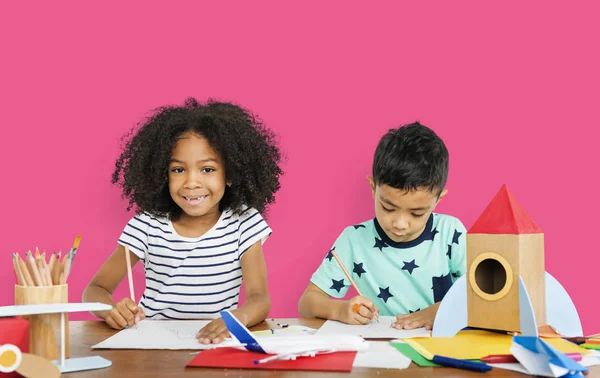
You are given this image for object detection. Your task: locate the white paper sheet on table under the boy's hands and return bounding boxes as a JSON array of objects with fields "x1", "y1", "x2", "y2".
[{"x1": 317, "y1": 316, "x2": 431, "y2": 339}]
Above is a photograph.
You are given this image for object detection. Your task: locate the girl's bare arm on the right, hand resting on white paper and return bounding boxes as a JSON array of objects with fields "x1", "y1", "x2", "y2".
[{"x1": 197, "y1": 240, "x2": 271, "y2": 344}]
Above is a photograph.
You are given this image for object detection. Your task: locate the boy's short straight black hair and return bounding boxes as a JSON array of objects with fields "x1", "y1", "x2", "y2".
[{"x1": 373, "y1": 122, "x2": 448, "y2": 195}]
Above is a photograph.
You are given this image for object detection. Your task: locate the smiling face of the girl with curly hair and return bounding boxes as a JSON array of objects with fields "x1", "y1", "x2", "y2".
[{"x1": 169, "y1": 132, "x2": 226, "y2": 218}]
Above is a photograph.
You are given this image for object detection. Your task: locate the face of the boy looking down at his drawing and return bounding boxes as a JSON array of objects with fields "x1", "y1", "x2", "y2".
[{"x1": 368, "y1": 177, "x2": 447, "y2": 242}]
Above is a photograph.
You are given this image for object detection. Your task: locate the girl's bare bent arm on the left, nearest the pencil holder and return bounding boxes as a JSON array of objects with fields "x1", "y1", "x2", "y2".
[{"x1": 82, "y1": 244, "x2": 140, "y2": 320}]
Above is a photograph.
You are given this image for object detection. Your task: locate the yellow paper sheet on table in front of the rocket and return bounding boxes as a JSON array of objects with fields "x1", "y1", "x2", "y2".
[{"x1": 404, "y1": 330, "x2": 590, "y2": 360}]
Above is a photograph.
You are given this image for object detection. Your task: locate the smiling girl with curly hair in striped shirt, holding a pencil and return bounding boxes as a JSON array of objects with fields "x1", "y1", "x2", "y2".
[{"x1": 83, "y1": 98, "x2": 282, "y2": 344}]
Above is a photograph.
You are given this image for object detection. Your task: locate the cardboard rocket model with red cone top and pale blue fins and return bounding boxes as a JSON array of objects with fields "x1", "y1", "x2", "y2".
[{"x1": 432, "y1": 185, "x2": 583, "y2": 337}]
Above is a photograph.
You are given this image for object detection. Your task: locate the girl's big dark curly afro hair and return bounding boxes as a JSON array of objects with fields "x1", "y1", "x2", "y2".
[{"x1": 112, "y1": 97, "x2": 283, "y2": 219}]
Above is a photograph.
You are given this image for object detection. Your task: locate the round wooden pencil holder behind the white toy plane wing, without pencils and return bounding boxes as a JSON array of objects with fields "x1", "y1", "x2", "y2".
[{"x1": 15, "y1": 284, "x2": 69, "y2": 361}]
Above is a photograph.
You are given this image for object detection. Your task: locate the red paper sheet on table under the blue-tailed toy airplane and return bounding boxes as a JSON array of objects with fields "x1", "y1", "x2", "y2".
[{"x1": 187, "y1": 348, "x2": 356, "y2": 371}]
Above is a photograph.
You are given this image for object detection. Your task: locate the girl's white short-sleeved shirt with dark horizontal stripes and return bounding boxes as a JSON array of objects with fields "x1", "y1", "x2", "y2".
[{"x1": 119, "y1": 208, "x2": 272, "y2": 319}]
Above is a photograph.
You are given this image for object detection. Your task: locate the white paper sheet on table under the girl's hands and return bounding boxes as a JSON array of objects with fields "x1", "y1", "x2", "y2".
[{"x1": 92, "y1": 319, "x2": 237, "y2": 350}]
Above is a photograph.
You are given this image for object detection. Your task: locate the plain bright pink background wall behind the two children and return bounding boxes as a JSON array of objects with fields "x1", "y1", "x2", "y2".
[{"x1": 0, "y1": 1, "x2": 600, "y2": 333}]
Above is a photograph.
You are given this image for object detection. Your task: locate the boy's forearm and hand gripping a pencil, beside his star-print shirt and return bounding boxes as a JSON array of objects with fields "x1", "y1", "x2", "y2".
[{"x1": 298, "y1": 282, "x2": 377, "y2": 324}]
